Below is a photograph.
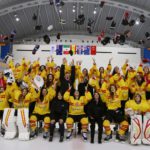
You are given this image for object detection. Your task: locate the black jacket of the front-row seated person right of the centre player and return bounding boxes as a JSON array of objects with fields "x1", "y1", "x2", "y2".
[{"x1": 87, "y1": 99, "x2": 107, "y2": 118}]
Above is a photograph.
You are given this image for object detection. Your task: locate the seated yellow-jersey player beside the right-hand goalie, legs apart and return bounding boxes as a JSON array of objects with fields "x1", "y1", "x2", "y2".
[{"x1": 103, "y1": 85, "x2": 128, "y2": 141}]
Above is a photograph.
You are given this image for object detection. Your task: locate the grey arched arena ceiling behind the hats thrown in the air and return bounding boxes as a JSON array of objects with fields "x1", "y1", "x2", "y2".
[{"x1": 0, "y1": 0, "x2": 150, "y2": 47}]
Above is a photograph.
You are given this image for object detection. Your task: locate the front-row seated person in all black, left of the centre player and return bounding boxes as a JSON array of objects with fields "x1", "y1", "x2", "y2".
[{"x1": 49, "y1": 92, "x2": 67, "y2": 142}]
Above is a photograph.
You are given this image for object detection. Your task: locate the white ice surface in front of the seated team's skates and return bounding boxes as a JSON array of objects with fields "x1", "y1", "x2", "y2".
[{"x1": 0, "y1": 134, "x2": 150, "y2": 150}]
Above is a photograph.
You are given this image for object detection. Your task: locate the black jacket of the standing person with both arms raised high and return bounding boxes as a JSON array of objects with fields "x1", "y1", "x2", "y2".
[{"x1": 60, "y1": 65, "x2": 75, "y2": 95}]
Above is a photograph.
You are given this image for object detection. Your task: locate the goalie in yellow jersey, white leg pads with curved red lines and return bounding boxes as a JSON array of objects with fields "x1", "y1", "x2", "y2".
[{"x1": 125, "y1": 94, "x2": 150, "y2": 144}]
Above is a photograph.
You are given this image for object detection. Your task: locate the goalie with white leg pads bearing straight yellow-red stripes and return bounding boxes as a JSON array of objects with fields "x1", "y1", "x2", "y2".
[{"x1": 3, "y1": 87, "x2": 31, "y2": 140}]
